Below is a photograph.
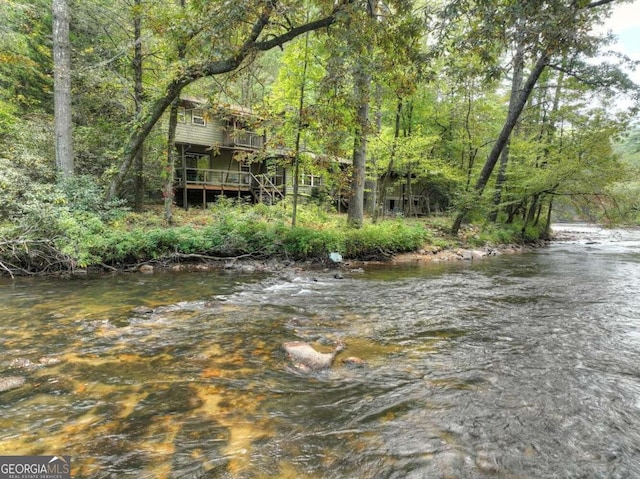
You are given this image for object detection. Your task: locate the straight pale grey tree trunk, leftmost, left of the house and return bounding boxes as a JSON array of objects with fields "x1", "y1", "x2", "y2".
[{"x1": 53, "y1": 0, "x2": 74, "y2": 178}]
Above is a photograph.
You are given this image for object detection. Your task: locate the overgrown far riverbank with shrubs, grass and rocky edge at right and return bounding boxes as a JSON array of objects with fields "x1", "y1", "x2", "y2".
[{"x1": 0, "y1": 205, "x2": 552, "y2": 277}]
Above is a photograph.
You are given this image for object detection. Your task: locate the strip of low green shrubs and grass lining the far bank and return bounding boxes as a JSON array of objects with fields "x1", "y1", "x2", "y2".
[{"x1": 0, "y1": 202, "x2": 537, "y2": 275}]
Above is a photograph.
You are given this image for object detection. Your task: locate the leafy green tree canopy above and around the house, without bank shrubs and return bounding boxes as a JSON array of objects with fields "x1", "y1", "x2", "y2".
[{"x1": 0, "y1": 0, "x2": 640, "y2": 232}]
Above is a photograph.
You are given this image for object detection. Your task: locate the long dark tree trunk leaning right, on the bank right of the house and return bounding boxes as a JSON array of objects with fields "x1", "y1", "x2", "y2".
[{"x1": 451, "y1": 53, "x2": 549, "y2": 234}]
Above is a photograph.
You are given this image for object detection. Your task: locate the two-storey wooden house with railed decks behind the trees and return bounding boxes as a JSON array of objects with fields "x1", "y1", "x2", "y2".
[{"x1": 175, "y1": 97, "x2": 330, "y2": 208}]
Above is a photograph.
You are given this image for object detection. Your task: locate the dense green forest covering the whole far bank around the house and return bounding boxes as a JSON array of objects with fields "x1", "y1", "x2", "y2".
[{"x1": 0, "y1": 0, "x2": 640, "y2": 275}]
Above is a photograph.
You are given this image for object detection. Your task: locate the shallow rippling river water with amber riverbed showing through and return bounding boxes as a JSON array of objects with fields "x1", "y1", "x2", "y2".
[{"x1": 0, "y1": 225, "x2": 640, "y2": 479}]
